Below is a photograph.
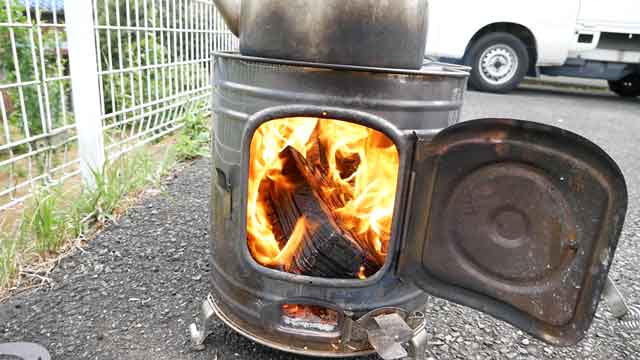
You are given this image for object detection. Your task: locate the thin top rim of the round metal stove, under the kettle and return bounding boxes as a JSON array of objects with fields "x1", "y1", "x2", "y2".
[{"x1": 213, "y1": 51, "x2": 471, "y2": 78}]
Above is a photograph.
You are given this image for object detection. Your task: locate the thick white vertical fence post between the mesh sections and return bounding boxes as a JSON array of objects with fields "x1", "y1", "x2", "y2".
[{"x1": 64, "y1": 0, "x2": 105, "y2": 186}]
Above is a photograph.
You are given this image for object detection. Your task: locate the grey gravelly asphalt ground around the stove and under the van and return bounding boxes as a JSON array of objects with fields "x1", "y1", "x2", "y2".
[{"x1": 0, "y1": 88, "x2": 640, "y2": 360}]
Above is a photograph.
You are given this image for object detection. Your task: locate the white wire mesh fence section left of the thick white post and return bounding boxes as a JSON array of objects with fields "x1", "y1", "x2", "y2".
[{"x1": 0, "y1": 0, "x2": 79, "y2": 207}]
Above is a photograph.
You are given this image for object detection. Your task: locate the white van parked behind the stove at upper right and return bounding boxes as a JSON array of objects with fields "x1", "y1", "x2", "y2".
[{"x1": 426, "y1": 0, "x2": 640, "y2": 96}]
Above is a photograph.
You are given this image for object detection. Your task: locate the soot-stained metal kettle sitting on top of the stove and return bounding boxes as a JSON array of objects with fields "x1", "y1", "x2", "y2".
[{"x1": 214, "y1": 0, "x2": 428, "y2": 69}]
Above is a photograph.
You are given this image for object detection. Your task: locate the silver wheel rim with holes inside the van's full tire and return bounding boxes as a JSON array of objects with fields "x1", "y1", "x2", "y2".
[{"x1": 479, "y1": 44, "x2": 518, "y2": 85}]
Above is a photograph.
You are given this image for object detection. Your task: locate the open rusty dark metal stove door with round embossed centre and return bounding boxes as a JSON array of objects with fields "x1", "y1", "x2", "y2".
[{"x1": 398, "y1": 119, "x2": 627, "y2": 345}]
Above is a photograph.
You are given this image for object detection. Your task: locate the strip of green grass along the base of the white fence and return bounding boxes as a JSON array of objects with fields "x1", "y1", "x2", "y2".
[{"x1": 0, "y1": 111, "x2": 209, "y2": 292}]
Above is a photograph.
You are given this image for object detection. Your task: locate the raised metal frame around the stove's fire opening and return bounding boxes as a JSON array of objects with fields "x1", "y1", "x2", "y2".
[{"x1": 239, "y1": 104, "x2": 415, "y2": 288}]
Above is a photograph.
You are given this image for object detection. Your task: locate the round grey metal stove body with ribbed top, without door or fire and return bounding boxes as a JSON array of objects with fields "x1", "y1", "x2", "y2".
[{"x1": 211, "y1": 55, "x2": 467, "y2": 356}]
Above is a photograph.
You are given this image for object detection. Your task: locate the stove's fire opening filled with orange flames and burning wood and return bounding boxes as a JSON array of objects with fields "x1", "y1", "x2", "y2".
[{"x1": 247, "y1": 117, "x2": 399, "y2": 279}]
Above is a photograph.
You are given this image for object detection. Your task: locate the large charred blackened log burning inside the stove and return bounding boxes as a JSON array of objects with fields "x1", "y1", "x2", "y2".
[{"x1": 269, "y1": 147, "x2": 379, "y2": 278}]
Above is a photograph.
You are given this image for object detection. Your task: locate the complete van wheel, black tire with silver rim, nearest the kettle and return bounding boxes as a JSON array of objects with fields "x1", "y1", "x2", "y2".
[{"x1": 465, "y1": 32, "x2": 530, "y2": 93}]
